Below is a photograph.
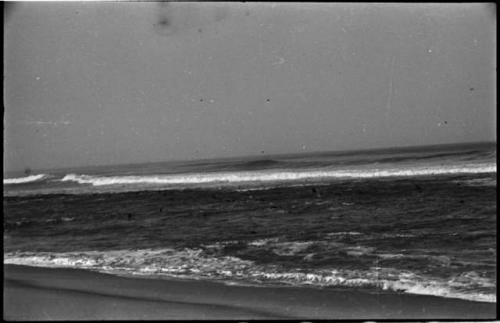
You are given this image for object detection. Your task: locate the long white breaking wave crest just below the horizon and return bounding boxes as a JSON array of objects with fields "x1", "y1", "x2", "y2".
[{"x1": 60, "y1": 163, "x2": 496, "y2": 186}]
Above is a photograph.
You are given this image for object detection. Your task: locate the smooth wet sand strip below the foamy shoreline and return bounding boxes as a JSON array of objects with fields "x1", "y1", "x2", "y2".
[{"x1": 4, "y1": 265, "x2": 496, "y2": 320}]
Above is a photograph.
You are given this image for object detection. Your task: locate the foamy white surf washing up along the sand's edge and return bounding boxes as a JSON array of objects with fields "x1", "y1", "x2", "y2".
[{"x1": 4, "y1": 248, "x2": 496, "y2": 302}]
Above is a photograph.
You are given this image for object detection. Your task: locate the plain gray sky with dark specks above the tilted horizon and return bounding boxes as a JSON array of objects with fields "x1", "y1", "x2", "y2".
[{"x1": 4, "y1": 2, "x2": 496, "y2": 175}]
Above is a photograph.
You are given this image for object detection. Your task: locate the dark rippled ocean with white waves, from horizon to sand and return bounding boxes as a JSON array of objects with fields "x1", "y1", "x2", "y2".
[{"x1": 3, "y1": 143, "x2": 497, "y2": 302}]
